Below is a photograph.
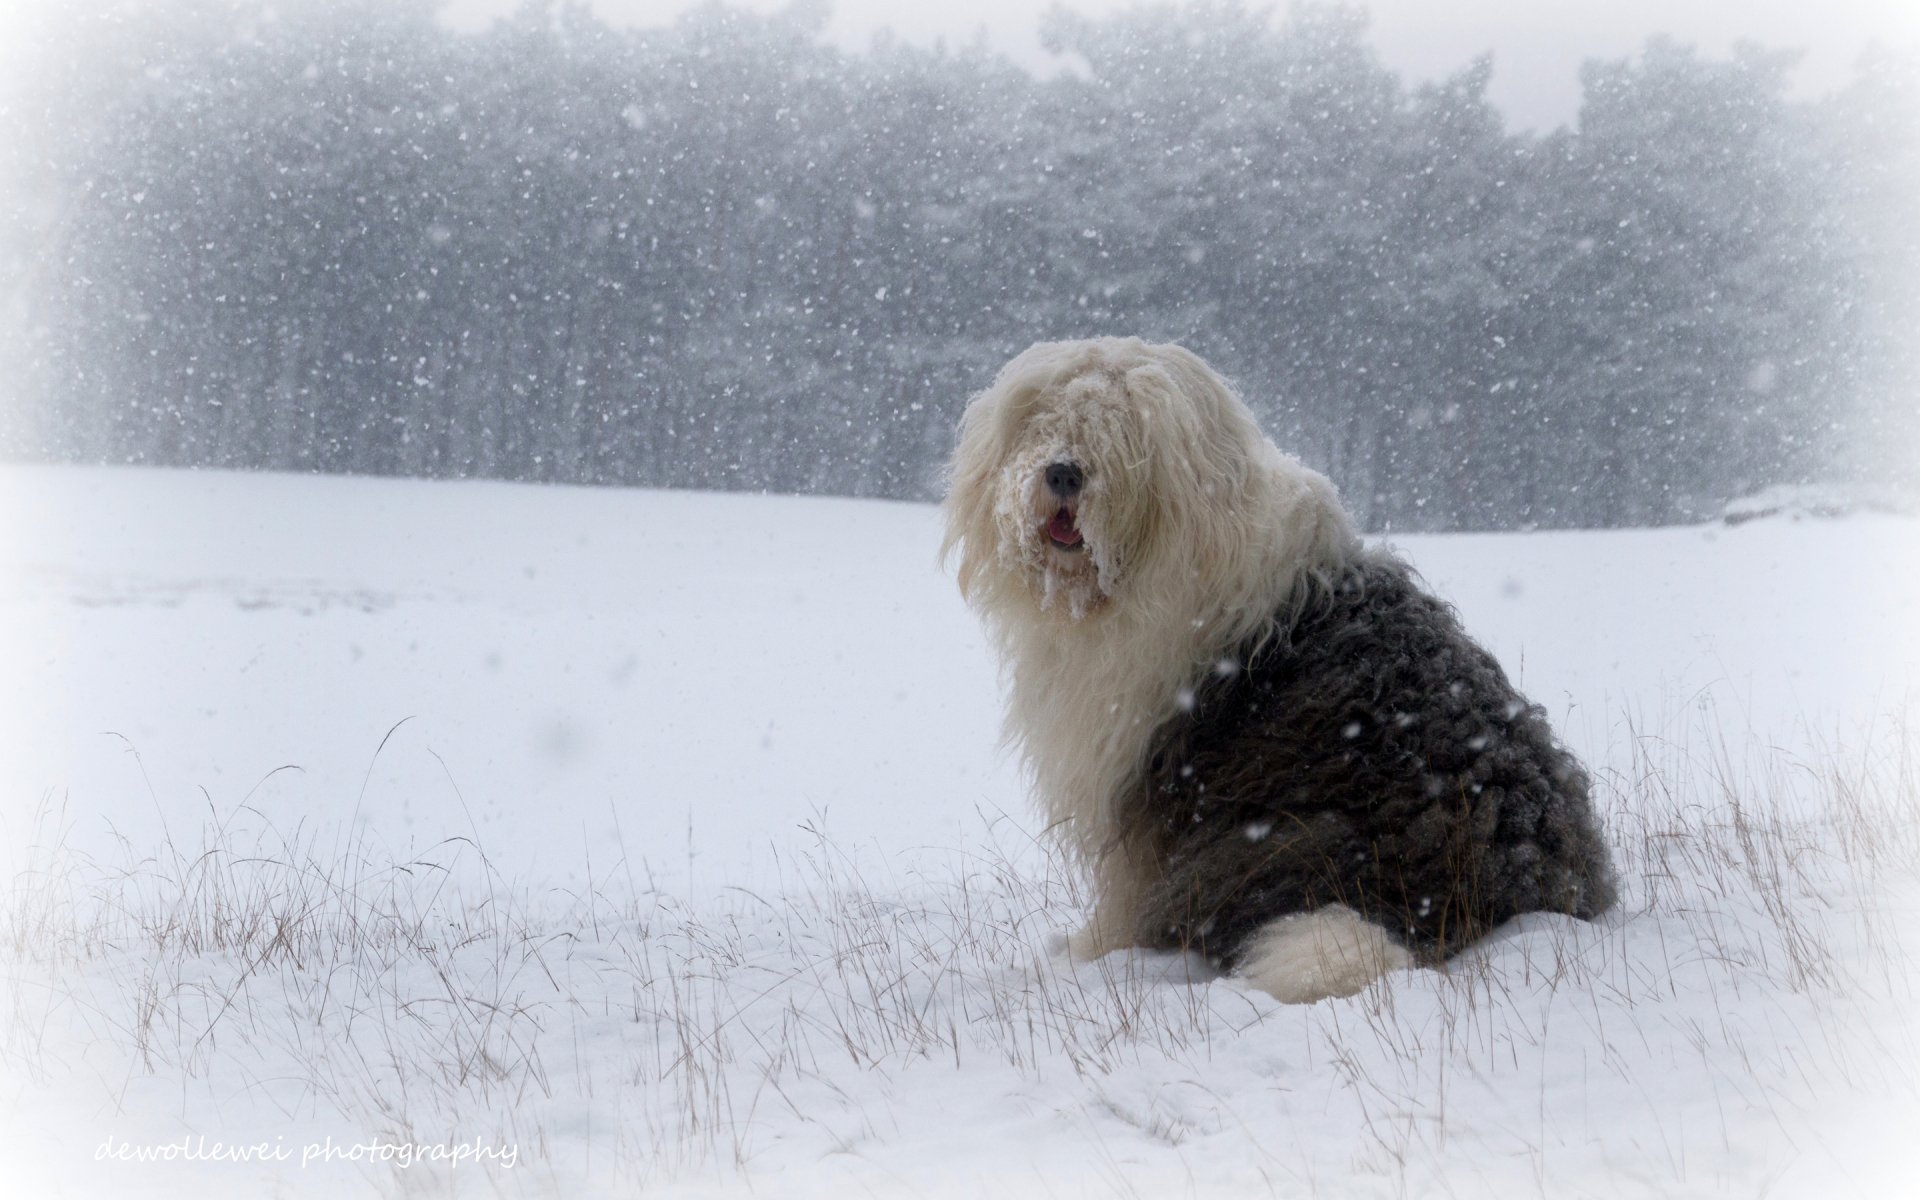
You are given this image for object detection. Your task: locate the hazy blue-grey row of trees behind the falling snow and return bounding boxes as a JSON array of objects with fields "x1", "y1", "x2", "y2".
[{"x1": 0, "y1": 0, "x2": 1920, "y2": 530}]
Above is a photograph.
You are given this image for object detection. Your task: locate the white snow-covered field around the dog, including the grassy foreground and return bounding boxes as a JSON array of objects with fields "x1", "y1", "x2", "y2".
[{"x1": 0, "y1": 467, "x2": 1920, "y2": 1200}]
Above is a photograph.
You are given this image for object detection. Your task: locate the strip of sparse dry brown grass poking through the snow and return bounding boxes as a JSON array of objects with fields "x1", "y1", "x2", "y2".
[{"x1": 0, "y1": 710, "x2": 1920, "y2": 1194}]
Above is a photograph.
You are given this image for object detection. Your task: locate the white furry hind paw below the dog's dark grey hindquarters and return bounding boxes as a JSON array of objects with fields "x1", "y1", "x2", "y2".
[{"x1": 1238, "y1": 904, "x2": 1413, "y2": 1004}]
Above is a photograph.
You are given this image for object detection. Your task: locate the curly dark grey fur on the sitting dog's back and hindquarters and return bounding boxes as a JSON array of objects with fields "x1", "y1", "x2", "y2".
[{"x1": 1119, "y1": 551, "x2": 1615, "y2": 966}]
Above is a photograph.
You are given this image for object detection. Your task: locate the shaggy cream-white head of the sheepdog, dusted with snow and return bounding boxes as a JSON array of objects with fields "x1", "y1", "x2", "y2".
[{"x1": 947, "y1": 338, "x2": 1279, "y2": 622}]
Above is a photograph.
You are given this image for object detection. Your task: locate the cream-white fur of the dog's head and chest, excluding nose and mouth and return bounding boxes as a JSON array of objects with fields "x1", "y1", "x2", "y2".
[{"x1": 941, "y1": 338, "x2": 1359, "y2": 941}]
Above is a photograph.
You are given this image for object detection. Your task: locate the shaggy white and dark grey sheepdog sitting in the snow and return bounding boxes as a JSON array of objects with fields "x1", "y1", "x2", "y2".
[{"x1": 945, "y1": 338, "x2": 1615, "y2": 1002}]
